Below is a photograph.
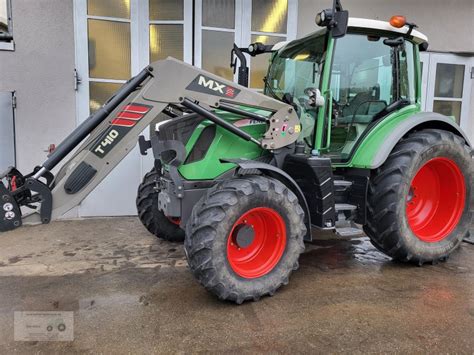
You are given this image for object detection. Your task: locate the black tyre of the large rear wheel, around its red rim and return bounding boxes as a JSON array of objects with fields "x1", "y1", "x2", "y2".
[{"x1": 364, "y1": 129, "x2": 474, "y2": 265}]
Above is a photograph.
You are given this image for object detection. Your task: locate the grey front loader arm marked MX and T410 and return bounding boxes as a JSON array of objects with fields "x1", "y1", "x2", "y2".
[{"x1": 0, "y1": 58, "x2": 301, "y2": 232}]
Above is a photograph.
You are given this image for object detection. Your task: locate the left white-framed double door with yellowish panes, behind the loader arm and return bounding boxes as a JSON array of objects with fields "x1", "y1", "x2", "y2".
[{"x1": 74, "y1": 0, "x2": 192, "y2": 217}]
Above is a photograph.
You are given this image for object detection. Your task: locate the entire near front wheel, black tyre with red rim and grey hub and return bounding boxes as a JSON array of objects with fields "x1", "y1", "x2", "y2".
[{"x1": 184, "y1": 176, "x2": 306, "y2": 304}]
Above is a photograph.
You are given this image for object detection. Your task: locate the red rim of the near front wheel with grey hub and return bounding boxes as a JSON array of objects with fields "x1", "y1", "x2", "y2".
[{"x1": 227, "y1": 207, "x2": 286, "y2": 279}]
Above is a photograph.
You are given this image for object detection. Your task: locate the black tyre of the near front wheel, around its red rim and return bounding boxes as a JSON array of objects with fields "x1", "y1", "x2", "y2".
[{"x1": 184, "y1": 175, "x2": 306, "y2": 304}]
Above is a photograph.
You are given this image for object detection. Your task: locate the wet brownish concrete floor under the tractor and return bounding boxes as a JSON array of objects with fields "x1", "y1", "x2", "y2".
[{"x1": 0, "y1": 218, "x2": 474, "y2": 354}]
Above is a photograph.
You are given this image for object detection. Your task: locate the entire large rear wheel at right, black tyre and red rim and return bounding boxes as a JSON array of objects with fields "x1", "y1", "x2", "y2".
[{"x1": 364, "y1": 130, "x2": 474, "y2": 265}]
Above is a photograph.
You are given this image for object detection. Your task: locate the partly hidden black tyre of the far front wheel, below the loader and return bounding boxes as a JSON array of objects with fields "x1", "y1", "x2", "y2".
[{"x1": 136, "y1": 169, "x2": 185, "y2": 243}]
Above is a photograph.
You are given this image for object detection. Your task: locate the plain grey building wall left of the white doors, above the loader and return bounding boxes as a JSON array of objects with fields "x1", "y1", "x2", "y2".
[{"x1": 0, "y1": 0, "x2": 76, "y2": 172}]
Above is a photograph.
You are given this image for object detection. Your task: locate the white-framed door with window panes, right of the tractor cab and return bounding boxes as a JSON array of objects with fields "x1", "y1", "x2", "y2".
[{"x1": 425, "y1": 53, "x2": 472, "y2": 132}]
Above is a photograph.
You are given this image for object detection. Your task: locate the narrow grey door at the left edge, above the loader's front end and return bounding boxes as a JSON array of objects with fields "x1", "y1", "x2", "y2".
[{"x1": 0, "y1": 91, "x2": 15, "y2": 173}]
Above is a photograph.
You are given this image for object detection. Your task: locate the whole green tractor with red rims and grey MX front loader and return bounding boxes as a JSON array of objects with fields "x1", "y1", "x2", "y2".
[{"x1": 0, "y1": 0, "x2": 474, "y2": 304}]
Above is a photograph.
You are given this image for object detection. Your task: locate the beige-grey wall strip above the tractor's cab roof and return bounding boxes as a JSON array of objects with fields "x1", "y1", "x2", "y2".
[{"x1": 298, "y1": 0, "x2": 474, "y2": 53}]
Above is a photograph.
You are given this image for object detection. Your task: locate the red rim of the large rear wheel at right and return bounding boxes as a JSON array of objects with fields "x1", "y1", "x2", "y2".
[{"x1": 406, "y1": 158, "x2": 466, "y2": 243}]
